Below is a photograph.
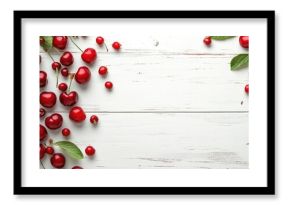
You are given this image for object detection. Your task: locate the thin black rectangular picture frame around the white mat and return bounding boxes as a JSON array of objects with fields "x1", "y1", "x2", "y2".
[{"x1": 14, "y1": 11, "x2": 275, "y2": 195}]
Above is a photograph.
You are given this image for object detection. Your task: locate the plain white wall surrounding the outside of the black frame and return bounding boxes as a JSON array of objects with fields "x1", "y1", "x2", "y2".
[{"x1": 0, "y1": 0, "x2": 290, "y2": 205}]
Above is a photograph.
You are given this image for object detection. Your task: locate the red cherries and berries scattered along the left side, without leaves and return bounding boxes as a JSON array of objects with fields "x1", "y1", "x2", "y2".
[{"x1": 39, "y1": 36, "x2": 121, "y2": 169}]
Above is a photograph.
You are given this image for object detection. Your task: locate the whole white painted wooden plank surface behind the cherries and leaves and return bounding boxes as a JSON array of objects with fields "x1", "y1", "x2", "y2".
[{"x1": 40, "y1": 35, "x2": 249, "y2": 169}]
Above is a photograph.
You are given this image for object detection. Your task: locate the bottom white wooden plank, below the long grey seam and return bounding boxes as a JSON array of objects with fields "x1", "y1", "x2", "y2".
[{"x1": 43, "y1": 113, "x2": 248, "y2": 169}]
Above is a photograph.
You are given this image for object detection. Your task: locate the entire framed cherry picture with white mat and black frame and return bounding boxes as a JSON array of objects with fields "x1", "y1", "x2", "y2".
[{"x1": 14, "y1": 11, "x2": 275, "y2": 195}]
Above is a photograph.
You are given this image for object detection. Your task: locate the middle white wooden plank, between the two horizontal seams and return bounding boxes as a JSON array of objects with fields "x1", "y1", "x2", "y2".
[{"x1": 41, "y1": 52, "x2": 248, "y2": 112}]
